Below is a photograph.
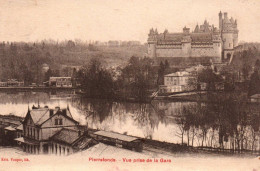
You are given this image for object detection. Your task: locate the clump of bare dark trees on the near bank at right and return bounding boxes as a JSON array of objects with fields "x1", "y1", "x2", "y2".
[{"x1": 175, "y1": 94, "x2": 260, "y2": 151}]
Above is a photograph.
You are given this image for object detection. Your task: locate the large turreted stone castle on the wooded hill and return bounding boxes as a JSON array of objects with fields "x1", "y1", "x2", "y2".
[{"x1": 148, "y1": 11, "x2": 238, "y2": 63}]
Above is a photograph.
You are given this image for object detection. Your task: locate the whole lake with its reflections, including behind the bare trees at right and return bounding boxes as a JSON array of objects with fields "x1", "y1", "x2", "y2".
[{"x1": 0, "y1": 92, "x2": 260, "y2": 150}]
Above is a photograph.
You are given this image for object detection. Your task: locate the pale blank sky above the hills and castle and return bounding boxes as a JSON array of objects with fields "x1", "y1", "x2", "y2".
[{"x1": 0, "y1": 0, "x2": 260, "y2": 42}]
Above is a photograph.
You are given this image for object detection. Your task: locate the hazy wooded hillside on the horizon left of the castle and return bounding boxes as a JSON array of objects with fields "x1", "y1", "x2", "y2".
[{"x1": 0, "y1": 40, "x2": 145, "y2": 85}]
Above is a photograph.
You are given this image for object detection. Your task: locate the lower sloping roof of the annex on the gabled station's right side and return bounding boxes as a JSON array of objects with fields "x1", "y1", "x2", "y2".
[{"x1": 50, "y1": 128, "x2": 79, "y2": 144}]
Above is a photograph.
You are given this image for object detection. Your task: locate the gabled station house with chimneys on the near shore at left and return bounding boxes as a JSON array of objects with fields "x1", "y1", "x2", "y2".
[{"x1": 16, "y1": 105, "x2": 95, "y2": 155}]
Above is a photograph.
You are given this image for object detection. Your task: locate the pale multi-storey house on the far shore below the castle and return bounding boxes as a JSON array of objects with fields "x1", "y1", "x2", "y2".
[{"x1": 159, "y1": 71, "x2": 191, "y2": 93}]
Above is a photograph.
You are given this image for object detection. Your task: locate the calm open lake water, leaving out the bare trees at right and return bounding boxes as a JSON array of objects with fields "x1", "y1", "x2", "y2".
[{"x1": 0, "y1": 92, "x2": 259, "y2": 149}]
